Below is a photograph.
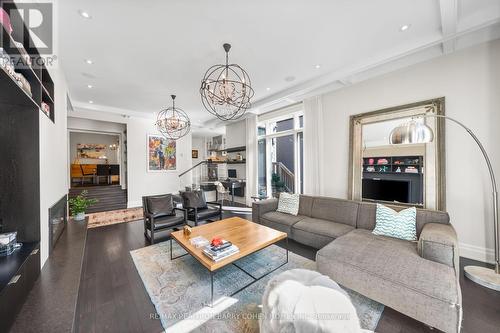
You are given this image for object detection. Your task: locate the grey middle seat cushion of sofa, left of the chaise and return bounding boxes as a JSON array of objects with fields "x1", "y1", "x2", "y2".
[{"x1": 292, "y1": 217, "x2": 354, "y2": 249}]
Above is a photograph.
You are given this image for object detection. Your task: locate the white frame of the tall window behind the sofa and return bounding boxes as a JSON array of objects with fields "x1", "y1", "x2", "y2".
[{"x1": 257, "y1": 110, "x2": 304, "y2": 195}]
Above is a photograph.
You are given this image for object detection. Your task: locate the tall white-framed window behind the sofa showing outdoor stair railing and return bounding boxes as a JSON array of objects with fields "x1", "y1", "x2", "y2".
[{"x1": 257, "y1": 111, "x2": 304, "y2": 196}]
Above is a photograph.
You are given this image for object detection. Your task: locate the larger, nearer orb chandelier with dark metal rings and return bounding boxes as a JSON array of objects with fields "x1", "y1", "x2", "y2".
[{"x1": 200, "y1": 43, "x2": 254, "y2": 121}]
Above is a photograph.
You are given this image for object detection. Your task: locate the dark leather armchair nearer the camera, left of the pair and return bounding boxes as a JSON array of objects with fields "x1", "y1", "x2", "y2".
[{"x1": 142, "y1": 194, "x2": 187, "y2": 244}]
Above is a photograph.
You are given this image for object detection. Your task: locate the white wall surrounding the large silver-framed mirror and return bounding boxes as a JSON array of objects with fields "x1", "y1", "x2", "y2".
[{"x1": 322, "y1": 40, "x2": 500, "y2": 261}]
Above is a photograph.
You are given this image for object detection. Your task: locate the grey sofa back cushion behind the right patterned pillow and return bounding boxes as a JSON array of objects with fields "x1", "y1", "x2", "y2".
[{"x1": 356, "y1": 202, "x2": 450, "y2": 237}]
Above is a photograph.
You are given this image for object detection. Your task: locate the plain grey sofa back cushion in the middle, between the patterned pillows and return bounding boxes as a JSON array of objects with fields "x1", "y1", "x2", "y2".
[{"x1": 311, "y1": 197, "x2": 358, "y2": 227}]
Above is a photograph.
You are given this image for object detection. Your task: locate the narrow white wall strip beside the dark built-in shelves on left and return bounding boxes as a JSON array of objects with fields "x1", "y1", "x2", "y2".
[{"x1": 39, "y1": 68, "x2": 69, "y2": 266}]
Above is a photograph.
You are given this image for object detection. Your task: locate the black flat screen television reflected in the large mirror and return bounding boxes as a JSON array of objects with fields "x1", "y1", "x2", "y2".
[{"x1": 361, "y1": 178, "x2": 410, "y2": 203}]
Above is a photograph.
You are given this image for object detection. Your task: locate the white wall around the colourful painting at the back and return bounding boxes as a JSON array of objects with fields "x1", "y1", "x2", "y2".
[{"x1": 127, "y1": 118, "x2": 192, "y2": 207}]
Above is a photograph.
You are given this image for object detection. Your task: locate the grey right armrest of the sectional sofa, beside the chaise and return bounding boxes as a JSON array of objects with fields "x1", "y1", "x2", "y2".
[{"x1": 418, "y1": 223, "x2": 459, "y2": 272}]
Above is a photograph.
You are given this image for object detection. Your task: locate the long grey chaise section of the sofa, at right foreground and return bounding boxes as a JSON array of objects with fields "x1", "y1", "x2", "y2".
[{"x1": 316, "y1": 229, "x2": 461, "y2": 332}]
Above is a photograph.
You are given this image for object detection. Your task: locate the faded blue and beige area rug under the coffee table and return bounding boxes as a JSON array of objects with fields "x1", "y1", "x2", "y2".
[{"x1": 130, "y1": 242, "x2": 384, "y2": 333}]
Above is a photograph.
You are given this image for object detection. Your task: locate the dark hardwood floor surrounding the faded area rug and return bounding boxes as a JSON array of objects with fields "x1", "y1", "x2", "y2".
[{"x1": 75, "y1": 216, "x2": 500, "y2": 333}]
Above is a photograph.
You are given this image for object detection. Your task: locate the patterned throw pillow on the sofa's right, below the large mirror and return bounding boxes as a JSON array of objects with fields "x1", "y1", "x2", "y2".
[{"x1": 372, "y1": 204, "x2": 417, "y2": 241}]
